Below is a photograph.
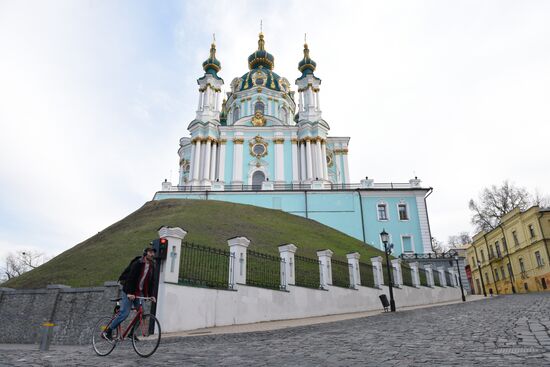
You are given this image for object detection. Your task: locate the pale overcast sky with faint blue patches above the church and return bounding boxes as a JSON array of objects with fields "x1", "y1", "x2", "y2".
[{"x1": 0, "y1": 0, "x2": 550, "y2": 259}]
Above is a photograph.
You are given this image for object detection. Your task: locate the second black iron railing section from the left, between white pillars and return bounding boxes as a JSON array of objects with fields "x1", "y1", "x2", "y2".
[{"x1": 246, "y1": 250, "x2": 286, "y2": 289}]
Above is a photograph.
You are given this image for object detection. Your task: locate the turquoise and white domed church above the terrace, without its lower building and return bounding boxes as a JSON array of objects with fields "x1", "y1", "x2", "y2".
[{"x1": 179, "y1": 33, "x2": 349, "y2": 188}]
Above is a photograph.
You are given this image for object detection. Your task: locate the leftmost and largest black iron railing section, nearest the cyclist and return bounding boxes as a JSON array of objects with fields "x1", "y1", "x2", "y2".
[{"x1": 181, "y1": 242, "x2": 233, "y2": 289}]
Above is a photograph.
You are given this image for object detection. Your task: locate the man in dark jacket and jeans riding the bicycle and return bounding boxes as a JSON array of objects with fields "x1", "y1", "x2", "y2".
[{"x1": 101, "y1": 246, "x2": 156, "y2": 341}]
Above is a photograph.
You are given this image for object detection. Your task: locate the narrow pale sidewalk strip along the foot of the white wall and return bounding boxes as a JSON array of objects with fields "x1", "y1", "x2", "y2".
[{"x1": 162, "y1": 295, "x2": 488, "y2": 338}]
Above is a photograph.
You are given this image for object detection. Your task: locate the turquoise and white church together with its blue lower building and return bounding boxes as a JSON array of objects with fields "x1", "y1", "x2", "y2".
[{"x1": 154, "y1": 33, "x2": 432, "y2": 255}]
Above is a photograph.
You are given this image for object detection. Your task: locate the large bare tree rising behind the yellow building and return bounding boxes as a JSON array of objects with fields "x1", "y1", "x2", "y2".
[{"x1": 469, "y1": 180, "x2": 532, "y2": 232}]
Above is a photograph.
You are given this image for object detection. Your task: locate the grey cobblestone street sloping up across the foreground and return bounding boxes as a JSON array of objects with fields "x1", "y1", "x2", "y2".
[{"x1": 0, "y1": 293, "x2": 550, "y2": 367}]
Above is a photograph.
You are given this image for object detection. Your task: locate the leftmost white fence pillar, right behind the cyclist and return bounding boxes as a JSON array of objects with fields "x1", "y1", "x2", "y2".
[{"x1": 156, "y1": 227, "x2": 187, "y2": 325}]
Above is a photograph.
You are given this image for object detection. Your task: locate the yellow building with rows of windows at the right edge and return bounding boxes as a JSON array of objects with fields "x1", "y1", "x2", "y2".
[{"x1": 466, "y1": 206, "x2": 550, "y2": 294}]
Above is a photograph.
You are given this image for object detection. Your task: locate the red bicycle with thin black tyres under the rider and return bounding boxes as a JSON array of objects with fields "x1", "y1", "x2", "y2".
[{"x1": 92, "y1": 297, "x2": 161, "y2": 357}]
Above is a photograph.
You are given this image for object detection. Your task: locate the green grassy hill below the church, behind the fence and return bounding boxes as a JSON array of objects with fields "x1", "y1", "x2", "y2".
[{"x1": 3, "y1": 200, "x2": 382, "y2": 288}]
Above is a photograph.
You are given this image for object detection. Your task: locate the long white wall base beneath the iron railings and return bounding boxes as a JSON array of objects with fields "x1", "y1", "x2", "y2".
[{"x1": 158, "y1": 283, "x2": 461, "y2": 332}]
